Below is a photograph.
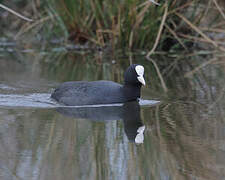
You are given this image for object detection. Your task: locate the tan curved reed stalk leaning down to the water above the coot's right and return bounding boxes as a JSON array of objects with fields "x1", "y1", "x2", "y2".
[{"x1": 146, "y1": 2, "x2": 168, "y2": 57}]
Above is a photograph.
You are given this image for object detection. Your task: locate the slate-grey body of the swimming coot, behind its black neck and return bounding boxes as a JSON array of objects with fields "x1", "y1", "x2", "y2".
[{"x1": 51, "y1": 81, "x2": 126, "y2": 106}]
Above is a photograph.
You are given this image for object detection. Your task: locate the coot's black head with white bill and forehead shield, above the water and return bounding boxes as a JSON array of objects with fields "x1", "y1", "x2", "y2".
[{"x1": 124, "y1": 64, "x2": 145, "y2": 86}]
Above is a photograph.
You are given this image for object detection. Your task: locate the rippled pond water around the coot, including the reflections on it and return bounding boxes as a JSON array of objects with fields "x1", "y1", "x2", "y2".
[{"x1": 0, "y1": 48, "x2": 225, "y2": 180}]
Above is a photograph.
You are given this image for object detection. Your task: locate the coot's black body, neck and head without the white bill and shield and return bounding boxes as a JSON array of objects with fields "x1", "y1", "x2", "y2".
[{"x1": 51, "y1": 64, "x2": 145, "y2": 106}]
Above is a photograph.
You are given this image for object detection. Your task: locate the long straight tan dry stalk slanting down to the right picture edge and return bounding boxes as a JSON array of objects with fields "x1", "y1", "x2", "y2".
[{"x1": 175, "y1": 12, "x2": 225, "y2": 51}]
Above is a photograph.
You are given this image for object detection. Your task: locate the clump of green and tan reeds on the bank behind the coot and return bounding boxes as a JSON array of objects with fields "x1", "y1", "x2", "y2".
[{"x1": 49, "y1": 0, "x2": 167, "y2": 49}]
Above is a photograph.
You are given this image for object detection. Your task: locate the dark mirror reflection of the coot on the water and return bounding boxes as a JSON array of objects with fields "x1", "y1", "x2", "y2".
[{"x1": 57, "y1": 101, "x2": 145, "y2": 144}]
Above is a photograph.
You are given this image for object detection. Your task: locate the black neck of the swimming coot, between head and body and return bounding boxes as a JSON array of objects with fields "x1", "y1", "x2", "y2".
[{"x1": 123, "y1": 83, "x2": 141, "y2": 101}]
